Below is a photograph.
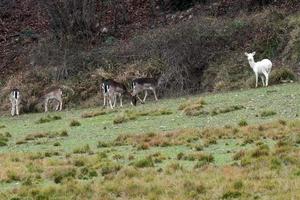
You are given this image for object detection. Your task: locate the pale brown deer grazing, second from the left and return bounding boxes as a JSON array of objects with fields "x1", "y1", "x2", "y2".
[{"x1": 42, "y1": 86, "x2": 74, "y2": 112}]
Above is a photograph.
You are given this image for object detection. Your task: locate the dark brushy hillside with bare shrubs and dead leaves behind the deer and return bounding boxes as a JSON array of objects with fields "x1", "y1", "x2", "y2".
[{"x1": 0, "y1": 0, "x2": 300, "y2": 111}]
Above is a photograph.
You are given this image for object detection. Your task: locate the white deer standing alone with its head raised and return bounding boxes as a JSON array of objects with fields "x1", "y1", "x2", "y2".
[{"x1": 245, "y1": 52, "x2": 272, "y2": 87}]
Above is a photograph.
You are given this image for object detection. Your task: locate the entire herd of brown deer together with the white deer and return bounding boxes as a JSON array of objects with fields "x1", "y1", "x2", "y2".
[{"x1": 9, "y1": 52, "x2": 272, "y2": 116}]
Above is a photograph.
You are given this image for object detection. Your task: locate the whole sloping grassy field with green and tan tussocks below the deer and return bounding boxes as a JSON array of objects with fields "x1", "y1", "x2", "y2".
[{"x1": 0, "y1": 84, "x2": 300, "y2": 199}]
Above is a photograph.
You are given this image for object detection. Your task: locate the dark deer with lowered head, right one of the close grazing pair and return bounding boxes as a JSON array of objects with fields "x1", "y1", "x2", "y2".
[{"x1": 131, "y1": 78, "x2": 158, "y2": 105}]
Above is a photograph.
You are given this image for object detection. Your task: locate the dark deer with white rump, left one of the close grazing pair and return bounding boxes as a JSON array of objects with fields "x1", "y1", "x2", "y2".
[{"x1": 102, "y1": 79, "x2": 130, "y2": 109}]
